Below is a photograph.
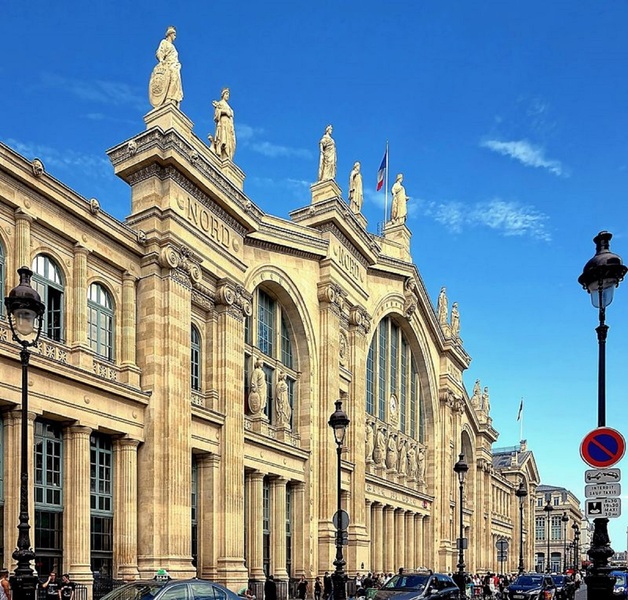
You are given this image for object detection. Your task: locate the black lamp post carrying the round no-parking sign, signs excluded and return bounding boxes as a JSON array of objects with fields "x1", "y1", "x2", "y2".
[{"x1": 578, "y1": 231, "x2": 628, "y2": 600}]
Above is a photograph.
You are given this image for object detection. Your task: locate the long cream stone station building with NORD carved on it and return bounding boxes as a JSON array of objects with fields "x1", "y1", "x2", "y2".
[{"x1": 0, "y1": 96, "x2": 539, "y2": 593}]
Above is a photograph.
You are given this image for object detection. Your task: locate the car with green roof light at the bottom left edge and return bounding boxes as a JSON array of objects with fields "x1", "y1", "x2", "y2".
[{"x1": 102, "y1": 579, "x2": 241, "y2": 600}]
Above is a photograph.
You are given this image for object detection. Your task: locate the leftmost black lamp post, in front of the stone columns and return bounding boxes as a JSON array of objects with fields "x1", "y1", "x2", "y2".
[{"x1": 4, "y1": 267, "x2": 45, "y2": 600}]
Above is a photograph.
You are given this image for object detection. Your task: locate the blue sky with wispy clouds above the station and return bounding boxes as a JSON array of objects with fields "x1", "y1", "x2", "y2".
[{"x1": 0, "y1": 0, "x2": 628, "y2": 550}]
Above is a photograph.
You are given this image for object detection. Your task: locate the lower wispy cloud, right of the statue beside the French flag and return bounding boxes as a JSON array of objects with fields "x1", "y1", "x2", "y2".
[{"x1": 417, "y1": 198, "x2": 552, "y2": 242}]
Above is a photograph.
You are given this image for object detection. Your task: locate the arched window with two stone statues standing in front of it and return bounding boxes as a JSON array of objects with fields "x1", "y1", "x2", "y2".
[{"x1": 244, "y1": 289, "x2": 297, "y2": 427}]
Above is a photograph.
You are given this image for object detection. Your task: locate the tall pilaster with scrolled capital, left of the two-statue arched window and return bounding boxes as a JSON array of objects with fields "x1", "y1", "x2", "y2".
[{"x1": 215, "y1": 279, "x2": 249, "y2": 590}]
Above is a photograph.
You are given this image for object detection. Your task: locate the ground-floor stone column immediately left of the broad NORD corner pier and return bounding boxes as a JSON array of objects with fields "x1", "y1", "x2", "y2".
[{"x1": 113, "y1": 438, "x2": 139, "y2": 580}]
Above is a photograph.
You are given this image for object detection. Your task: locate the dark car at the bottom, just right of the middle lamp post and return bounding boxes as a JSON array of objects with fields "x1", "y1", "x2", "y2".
[{"x1": 374, "y1": 571, "x2": 460, "y2": 600}]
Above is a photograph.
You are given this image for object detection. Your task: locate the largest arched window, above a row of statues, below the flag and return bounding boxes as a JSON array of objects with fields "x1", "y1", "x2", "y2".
[{"x1": 366, "y1": 317, "x2": 423, "y2": 442}]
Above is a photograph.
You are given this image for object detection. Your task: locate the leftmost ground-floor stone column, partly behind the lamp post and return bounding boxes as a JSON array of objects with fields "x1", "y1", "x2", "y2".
[{"x1": 2, "y1": 408, "x2": 36, "y2": 571}]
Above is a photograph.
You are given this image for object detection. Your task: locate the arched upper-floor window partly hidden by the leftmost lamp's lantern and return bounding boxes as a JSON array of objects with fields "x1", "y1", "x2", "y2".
[{"x1": 32, "y1": 254, "x2": 64, "y2": 342}]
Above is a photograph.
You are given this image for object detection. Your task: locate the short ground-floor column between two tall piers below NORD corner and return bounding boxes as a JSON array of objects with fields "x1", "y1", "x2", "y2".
[{"x1": 196, "y1": 454, "x2": 221, "y2": 581}]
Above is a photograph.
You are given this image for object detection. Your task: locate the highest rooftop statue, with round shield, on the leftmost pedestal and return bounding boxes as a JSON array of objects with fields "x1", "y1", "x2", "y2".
[{"x1": 148, "y1": 26, "x2": 183, "y2": 108}]
